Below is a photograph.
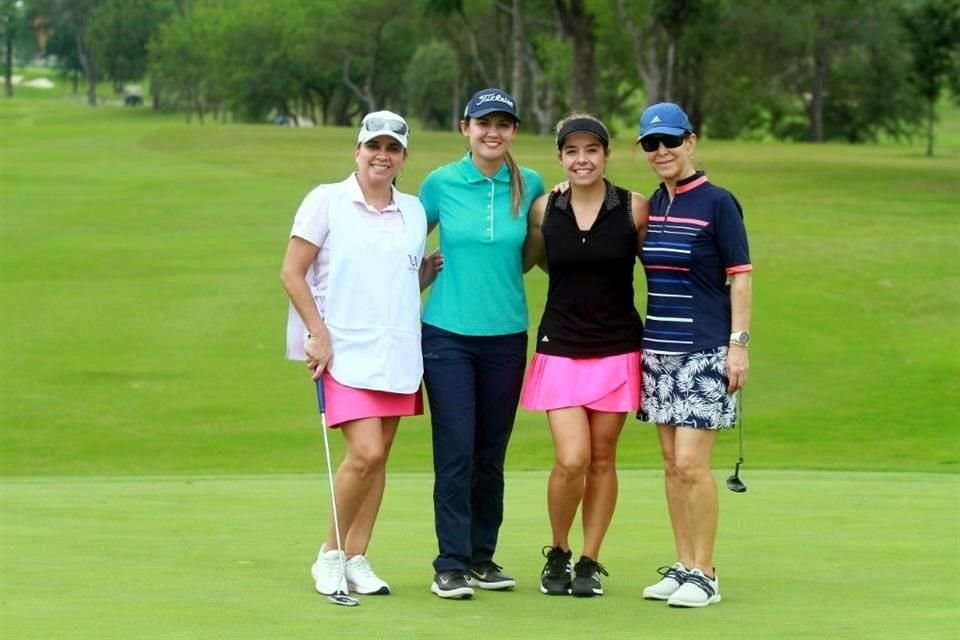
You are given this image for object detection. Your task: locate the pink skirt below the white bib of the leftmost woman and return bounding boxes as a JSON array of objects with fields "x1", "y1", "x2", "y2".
[{"x1": 323, "y1": 371, "x2": 423, "y2": 427}]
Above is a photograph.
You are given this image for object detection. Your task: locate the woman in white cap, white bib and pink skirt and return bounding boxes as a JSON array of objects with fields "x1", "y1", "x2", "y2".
[{"x1": 281, "y1": 111, "x2": 442, "y2": 595}]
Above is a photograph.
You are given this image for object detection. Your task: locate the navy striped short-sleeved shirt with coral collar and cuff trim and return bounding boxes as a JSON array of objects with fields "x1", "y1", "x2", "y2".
[{"x1": 641, "y1": 171, "x2": 753, "y2": 354}]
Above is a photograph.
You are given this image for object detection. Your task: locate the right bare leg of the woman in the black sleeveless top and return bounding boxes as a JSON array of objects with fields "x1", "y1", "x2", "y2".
[{"x1": 582, "y1": 410, "x2": 627, "y2": 560}]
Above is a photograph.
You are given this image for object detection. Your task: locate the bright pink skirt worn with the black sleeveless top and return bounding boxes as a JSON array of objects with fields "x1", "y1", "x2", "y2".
[{"x1": 520, "y1": 351, "x2": 640, "y2": 413}]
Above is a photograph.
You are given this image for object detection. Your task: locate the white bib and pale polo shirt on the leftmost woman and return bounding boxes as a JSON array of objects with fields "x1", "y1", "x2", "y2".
[{"x1": 287, "y1": 175, "x2": 426, "y2": 393}]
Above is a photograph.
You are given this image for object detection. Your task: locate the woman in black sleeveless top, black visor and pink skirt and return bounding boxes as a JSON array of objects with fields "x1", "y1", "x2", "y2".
[{"x1": 521, "y1": 114, "x2": 648, "y2": 597}]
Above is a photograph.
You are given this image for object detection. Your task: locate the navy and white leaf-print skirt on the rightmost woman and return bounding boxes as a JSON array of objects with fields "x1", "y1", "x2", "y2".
[{"x1": 637, "y1": 347, "x2": 737, "y2": 429}]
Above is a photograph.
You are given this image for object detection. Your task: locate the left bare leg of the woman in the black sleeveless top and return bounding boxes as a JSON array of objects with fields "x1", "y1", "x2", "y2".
[{"x1": 547, "y1": 407, "x2": 590, "y2": 551}]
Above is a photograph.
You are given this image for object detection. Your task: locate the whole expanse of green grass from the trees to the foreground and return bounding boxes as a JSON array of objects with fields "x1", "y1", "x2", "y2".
[{"x1": 0, "y1": 89, "x2": 960, "y2": 640}]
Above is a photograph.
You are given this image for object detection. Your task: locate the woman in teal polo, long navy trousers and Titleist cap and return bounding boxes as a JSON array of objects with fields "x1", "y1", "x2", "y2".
[{"x1": 420, "y1": 89, "x2": 544, "y2": 598}]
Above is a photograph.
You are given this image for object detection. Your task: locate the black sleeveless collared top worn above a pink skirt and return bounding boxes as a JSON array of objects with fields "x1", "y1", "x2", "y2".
[{"x1": 537, "y1": 180, "x2": 643, "y2": 358}]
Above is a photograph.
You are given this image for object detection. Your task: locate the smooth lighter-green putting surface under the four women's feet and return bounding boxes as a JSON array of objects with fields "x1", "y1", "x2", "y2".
[{"x1": 0, "y1": 471, "x2": 960, "y2": 640}]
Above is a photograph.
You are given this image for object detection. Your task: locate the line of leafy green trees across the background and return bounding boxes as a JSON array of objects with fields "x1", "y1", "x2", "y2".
[{"x1": 0, "y1": 0, "x2": 960, "y2": 152}]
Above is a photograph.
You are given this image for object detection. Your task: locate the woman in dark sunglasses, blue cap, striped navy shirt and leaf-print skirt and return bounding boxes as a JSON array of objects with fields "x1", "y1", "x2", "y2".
[{"x1": 638, "y1": 103, "x2": 752, "y2": 607}]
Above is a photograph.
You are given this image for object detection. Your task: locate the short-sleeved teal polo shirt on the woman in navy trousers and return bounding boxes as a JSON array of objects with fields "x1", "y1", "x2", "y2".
[{"x1": 420, "y1": 153, "x2": 544, "y2": 336}]
